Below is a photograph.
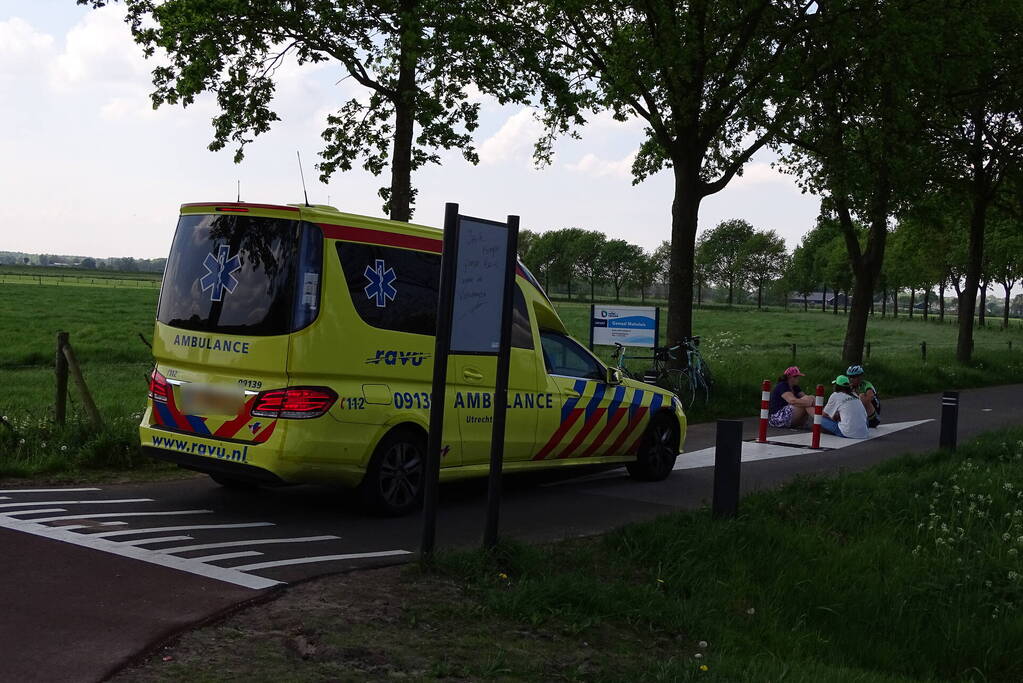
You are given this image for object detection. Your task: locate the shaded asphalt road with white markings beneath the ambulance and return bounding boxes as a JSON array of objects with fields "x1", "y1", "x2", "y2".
[{"x1": 0, "y1": 385, "x2": 1023, "y2": 682}]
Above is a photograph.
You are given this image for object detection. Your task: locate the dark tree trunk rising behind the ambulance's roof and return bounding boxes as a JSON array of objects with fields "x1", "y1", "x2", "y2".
[{"x1": 387, "y1": 0, "x2": 419, "y2": 222}]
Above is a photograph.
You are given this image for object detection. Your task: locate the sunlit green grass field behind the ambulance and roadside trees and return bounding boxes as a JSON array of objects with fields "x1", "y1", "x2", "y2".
[{"x1": 6, "y1": 283, "x2": 1023, "y2": 476}]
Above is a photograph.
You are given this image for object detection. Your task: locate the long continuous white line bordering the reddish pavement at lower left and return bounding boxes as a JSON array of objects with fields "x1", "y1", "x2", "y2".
[{"x1": 0, "y1": 516, "x2": 282, "y2": 590}]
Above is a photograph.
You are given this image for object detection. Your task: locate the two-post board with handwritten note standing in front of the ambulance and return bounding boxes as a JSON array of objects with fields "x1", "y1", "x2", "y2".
[{"x1": 420, "y1": 203, "x2": 519, "y2": 561}]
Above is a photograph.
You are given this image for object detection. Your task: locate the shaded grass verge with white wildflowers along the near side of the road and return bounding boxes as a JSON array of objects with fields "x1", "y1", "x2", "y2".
[{"x1": 114, "y1": 429, "x2": 1023, "y2": 683}]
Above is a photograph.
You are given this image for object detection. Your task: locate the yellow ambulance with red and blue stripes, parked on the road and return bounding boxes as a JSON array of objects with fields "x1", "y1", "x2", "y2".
[{"x1": 139, "y1": 202, "x2": 685, "y2": 514}]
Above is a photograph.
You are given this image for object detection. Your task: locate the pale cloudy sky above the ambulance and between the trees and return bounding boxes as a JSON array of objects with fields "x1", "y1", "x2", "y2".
[{"x1": 0, "y1": 0, "x2": 819, "y2": 258}]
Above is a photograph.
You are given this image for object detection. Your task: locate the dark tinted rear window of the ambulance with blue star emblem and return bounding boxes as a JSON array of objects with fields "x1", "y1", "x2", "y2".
[{"x1": 157, "y1": 214, "x2": 322, "y2": 335}]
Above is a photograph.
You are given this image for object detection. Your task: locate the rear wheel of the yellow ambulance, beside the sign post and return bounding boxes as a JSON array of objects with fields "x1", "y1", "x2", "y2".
[{"x1": 359, "y1": 428, "x2": 427, "y2": 516}]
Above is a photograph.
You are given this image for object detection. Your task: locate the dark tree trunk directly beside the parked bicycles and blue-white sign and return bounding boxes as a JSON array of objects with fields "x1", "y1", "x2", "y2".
[{"x1": 668, "y1": 164, "x2": 703, "y2": 345}]
